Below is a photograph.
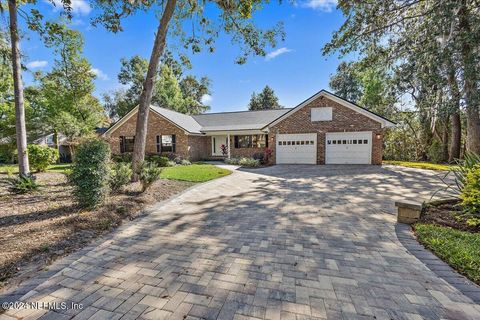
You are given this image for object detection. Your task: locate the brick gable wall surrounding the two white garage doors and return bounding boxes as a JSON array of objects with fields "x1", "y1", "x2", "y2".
[{"x1": 268, "y1": 96, "x2": 383, "y2": 164}]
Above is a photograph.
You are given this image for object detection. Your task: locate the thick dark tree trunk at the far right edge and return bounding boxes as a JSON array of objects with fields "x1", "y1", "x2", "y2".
[{"x1": 458, "y1": 0, "x2": 480, "y2": 154}]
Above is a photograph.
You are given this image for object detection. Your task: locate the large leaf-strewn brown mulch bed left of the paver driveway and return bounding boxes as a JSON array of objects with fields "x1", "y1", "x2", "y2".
[{"x1": 0, "y1": 172, "x2": 193, "y2": 289}]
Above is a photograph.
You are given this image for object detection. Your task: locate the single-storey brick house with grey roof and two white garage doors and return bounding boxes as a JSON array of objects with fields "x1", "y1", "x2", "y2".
[{"x1": 104, "y1": 90, "x2": 395, "y2": 164}]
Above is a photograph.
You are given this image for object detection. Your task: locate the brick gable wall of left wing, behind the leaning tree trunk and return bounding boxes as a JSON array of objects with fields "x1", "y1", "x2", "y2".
[{"x1": 108, "y1": 111, "x2": 189, "y2": 158}]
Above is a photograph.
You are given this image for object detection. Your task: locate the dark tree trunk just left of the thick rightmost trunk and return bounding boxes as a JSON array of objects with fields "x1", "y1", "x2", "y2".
[{"x1": 447, "y1": 53, "x2": 462, "y2": 162}]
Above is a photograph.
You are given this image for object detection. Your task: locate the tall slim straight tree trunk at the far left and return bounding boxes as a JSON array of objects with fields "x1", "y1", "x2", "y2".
[{"x1": 8, "y1": 0, "x2": 30, "y2": 177}]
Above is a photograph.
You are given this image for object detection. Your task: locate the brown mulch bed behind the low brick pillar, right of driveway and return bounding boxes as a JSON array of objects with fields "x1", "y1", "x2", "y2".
[{"x1": 419, "y1": 200, "x2": 480, "y2": 233}]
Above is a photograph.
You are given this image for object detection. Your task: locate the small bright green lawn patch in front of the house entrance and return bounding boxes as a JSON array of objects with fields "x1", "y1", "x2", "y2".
[{"x1": 161, "y1": 164, "x2": 232, "y2": 182}]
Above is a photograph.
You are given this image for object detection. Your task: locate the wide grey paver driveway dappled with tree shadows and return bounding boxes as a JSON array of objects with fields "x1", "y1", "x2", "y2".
[{"x1": 0, "y1": 166, "x2": 480, "y2": 319}]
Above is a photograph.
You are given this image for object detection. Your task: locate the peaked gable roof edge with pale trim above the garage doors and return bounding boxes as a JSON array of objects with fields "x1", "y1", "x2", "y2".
[{"x1": 262, "y1": 90, "x2": 396, "y2": 129}]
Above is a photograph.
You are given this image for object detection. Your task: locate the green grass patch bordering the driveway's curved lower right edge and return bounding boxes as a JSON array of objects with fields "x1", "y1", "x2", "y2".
[{"x1": 415, "y1": 223, "x2": 480, "y2": 284}]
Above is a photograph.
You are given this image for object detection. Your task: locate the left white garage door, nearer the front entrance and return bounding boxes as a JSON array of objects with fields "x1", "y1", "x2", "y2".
[{"x1": 276, "y1": 133, "x2": 317, "y2": 164}]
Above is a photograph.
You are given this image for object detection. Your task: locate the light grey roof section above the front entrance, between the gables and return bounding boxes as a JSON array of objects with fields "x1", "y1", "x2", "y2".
[{"x1": 151, "y1": 106, "x2": 290, "y2": 133}]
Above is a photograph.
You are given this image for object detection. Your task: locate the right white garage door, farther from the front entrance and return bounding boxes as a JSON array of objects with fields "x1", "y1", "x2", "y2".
[{"x1": 325, "y1": 131, "x2": 372, "y2": 164}]
